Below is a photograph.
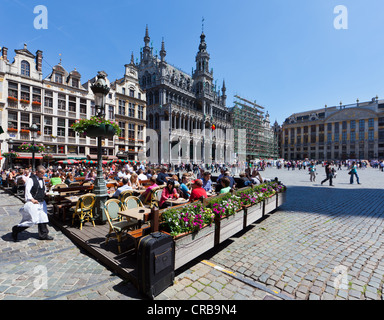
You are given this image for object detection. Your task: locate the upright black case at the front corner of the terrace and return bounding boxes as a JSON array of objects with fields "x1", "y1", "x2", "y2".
[{"x1": 137, "y1": 232, "x2": 175, "y2": 299}]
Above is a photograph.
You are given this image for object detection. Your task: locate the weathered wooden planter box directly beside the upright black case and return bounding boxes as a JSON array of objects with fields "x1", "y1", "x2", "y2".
[{"x1": 174, "y1": 224, "x2": 216, "y2": 269}]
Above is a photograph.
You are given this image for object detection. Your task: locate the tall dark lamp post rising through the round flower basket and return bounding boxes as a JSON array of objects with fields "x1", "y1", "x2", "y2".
[{"x1": 91, "y1": 73, "x2": 110, "y2": 223}]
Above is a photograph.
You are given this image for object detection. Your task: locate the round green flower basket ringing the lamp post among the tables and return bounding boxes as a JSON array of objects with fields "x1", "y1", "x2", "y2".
[{"x1": 71, "y1": 116, "x2": 121, "y2": 138}]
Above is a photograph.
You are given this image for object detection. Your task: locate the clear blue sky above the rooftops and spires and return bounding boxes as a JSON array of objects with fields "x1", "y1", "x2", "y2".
[{"x1": 0, "y1": 0, "x2": 384, "y2": 124}]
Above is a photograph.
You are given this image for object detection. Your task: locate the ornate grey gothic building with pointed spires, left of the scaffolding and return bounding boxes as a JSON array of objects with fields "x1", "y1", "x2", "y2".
[{"x1": 137, "y1": 26, "x2": 233, "y2": 164}]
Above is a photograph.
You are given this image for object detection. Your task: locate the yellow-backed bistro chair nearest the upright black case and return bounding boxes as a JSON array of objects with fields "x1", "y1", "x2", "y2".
[{"x1": 104, "y1": 199, "x2": 138, "y2": 253}]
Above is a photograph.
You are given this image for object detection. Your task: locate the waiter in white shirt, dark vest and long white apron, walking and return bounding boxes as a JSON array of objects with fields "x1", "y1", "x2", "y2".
[{"x1": 12, "y1": 166, "x2": 53, "y2": 241}]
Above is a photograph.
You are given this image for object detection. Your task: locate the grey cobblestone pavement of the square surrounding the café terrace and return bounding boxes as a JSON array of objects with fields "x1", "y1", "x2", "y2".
[{"x1": 0, "y1": 168, "x2": 384, "y2": 300}]
